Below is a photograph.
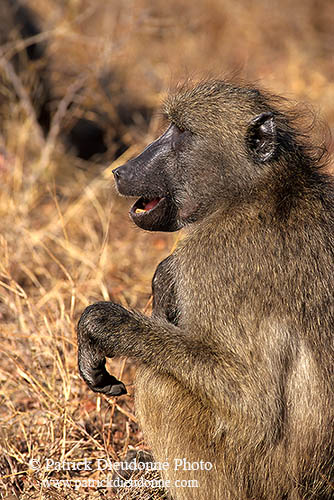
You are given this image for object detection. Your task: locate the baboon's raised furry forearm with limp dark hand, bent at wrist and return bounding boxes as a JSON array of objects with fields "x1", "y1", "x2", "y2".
[{"x1": 78, "y1": 302, "x2": 233, "y2": 406}]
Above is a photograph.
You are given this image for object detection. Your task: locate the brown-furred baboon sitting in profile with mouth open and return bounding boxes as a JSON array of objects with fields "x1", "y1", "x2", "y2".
[{"x1": 78, "y1": 80, "x2": 334, "y2": 500}]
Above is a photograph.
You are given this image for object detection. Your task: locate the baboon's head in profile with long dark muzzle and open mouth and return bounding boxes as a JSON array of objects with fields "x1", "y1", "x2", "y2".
[{"x1": 113, "y1": 82, "x2": 277, "y2": 231}]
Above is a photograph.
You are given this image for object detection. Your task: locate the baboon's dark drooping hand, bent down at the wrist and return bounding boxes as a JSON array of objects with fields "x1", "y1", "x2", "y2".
[{"x1": 78, "y1": 302, "x2": 131, "y2": 396}]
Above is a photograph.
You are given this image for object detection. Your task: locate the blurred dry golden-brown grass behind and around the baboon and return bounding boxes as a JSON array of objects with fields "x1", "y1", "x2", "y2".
[{"x1": 0, "y1": 0, "x2": 334, "y2": 499}]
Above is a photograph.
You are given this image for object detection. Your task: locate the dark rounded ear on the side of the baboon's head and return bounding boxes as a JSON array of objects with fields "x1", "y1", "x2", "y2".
[{"x1": 247, "y1": 112, "x2": 277, "y2": 162}]
